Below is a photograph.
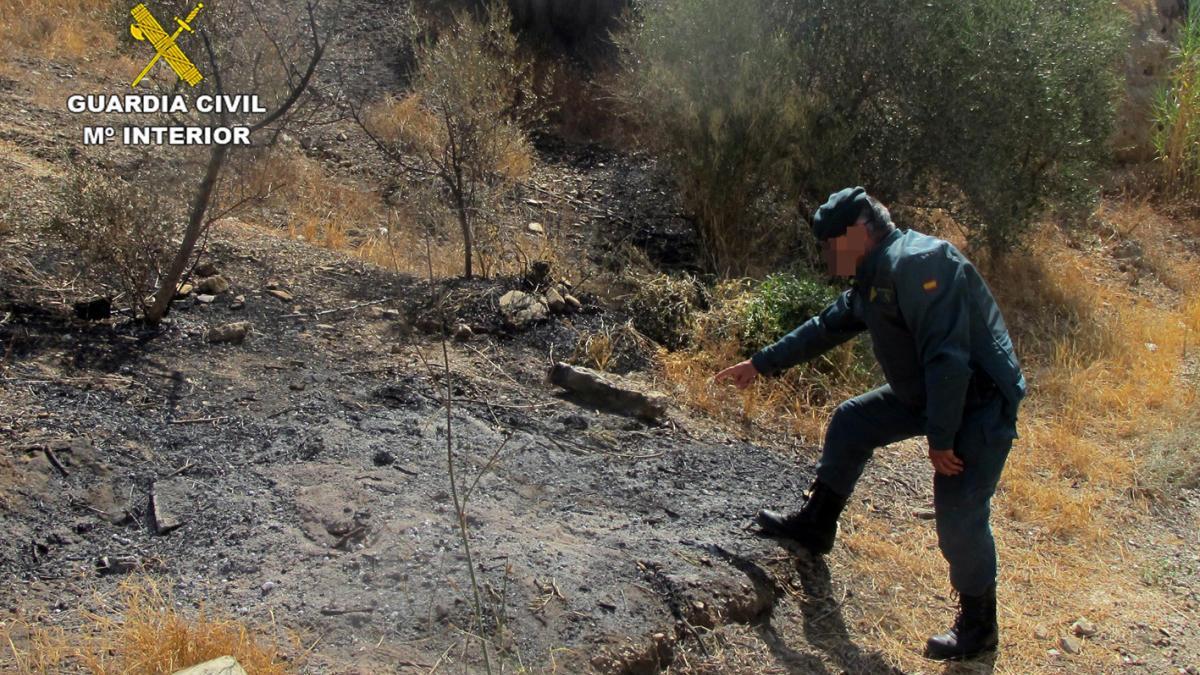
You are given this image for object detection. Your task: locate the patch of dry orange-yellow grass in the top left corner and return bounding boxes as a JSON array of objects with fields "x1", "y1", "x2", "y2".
[{"x1": 0, "y1": 0, "x2": 116, "y2": 59}]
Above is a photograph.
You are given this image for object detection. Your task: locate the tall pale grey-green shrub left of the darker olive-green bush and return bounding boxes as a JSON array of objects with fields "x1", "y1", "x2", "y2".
[{"x1": 616, "y1": 0, "x2": 815, "y2": 276}]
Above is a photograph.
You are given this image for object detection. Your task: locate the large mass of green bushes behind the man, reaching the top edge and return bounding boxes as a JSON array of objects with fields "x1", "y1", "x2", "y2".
[{"x1": 623, "y1": 0, "x2": 1128, "y2": 267}]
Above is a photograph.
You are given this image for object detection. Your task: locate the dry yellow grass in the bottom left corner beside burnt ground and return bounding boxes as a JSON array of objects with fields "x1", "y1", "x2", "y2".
[{"x1": 0, "y1": 579, "x2": 300, "y2": 675}]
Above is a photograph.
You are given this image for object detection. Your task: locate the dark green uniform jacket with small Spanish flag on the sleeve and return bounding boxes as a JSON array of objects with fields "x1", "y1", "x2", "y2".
[{"x1": 751, "y1": 229, "x2": 1026, "y2": 449}]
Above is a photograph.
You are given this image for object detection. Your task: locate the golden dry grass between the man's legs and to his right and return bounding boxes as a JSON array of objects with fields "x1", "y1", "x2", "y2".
[{"x1": 846, "y1": 207, "x2": 1200, "y2": 673}]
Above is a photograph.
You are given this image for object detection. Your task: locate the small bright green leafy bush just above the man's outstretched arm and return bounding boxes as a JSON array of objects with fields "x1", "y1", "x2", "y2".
[{"x1": 739, "y1": 273, "x2": 836, "y2": 354}]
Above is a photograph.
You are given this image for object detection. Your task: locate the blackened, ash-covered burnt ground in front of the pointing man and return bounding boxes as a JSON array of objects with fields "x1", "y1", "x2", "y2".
[{"x1": 0, "y1": 222, "x2": 902, "y2": 673}]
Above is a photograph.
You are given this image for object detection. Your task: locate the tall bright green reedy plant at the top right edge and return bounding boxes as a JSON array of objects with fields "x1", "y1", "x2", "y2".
[{"x1": 1153, "y1": 2, "x2": 1200, "y2": 192}]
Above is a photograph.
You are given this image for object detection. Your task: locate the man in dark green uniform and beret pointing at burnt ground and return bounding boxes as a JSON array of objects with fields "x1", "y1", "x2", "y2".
[{"x1": 716, "y1": 187, "x2": 1026, "y2": 659}]
